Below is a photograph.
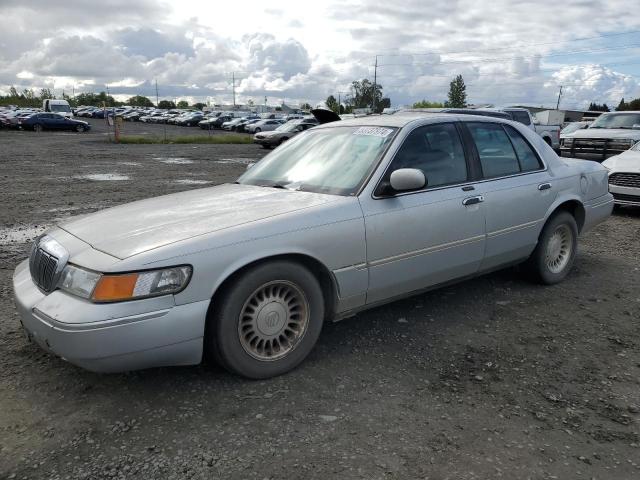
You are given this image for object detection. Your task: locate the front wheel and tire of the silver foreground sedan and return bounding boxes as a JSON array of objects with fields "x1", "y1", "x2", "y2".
[{"x1": 206, "y1": 261, "x2": 324, "y2": 379}]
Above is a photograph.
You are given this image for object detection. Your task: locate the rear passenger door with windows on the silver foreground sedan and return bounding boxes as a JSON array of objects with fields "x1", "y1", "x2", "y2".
[{"x1": 464, "y1": 122, "x2": 556, "y2": 270}]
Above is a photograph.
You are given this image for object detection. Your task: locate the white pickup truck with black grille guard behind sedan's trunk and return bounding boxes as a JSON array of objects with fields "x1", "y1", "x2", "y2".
[{"x1": 560, "y1": 111, "x2": 640, "y2": 162}]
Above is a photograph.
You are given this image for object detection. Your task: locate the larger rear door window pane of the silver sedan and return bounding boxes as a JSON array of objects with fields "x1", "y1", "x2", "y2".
[{"x1": 467, "y1": 122, "x2": 520, "y2": 178}]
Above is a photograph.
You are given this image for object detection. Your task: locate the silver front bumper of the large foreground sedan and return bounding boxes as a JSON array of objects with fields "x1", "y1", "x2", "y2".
[{"x1": 13, "y1": 261, "x2": 209, "y2": 372}]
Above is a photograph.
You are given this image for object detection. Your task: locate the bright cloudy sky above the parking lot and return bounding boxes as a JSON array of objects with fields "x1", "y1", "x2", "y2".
[{"x1": 0, "y1": 0, "x2": 640, "y2": 108}]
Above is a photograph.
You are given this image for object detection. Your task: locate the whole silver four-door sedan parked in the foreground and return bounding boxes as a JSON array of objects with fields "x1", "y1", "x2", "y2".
[{"x1": 13, "y1": 114, "x2": 613, "y2": 378}]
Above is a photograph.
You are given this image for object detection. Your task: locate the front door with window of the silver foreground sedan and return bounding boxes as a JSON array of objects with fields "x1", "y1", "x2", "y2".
[{"x1": 360, "y1": 122, "x2": 485, "y2": 303}]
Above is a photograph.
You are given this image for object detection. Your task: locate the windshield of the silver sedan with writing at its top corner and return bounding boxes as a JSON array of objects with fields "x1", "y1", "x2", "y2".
[{"x1": 238, "y1": 127, "x2": 397, "y2": 195}]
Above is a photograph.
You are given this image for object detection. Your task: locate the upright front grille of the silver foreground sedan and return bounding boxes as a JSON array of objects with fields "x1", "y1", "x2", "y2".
[{"x1": 29, "y1": 236, "x2": 69, "y2": 293}]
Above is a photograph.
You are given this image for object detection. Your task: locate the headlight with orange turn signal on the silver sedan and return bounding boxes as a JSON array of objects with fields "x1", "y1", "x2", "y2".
[{"x1": 60, "y1": 265, "x2": 192, "y2": 302}]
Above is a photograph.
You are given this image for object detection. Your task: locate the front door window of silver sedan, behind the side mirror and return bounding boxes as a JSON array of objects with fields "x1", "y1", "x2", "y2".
[{"x1": 389, "y1": 123, "x2": 467, "y2": 187}]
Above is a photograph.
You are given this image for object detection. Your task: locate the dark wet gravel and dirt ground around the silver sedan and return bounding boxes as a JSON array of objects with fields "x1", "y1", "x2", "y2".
[{"x1": 0, "y1": 120, "x2": 640, "y2": 480}]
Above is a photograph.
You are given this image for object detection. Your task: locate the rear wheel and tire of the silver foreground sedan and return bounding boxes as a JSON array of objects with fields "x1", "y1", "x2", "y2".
[{"x1": 525, "y1": 211, "x2": 578, "y2": 285}]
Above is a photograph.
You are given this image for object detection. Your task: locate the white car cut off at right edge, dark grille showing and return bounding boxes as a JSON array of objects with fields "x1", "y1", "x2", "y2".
[{"x1": 602, "y1": 142, "x2": 640, "y2": 207}]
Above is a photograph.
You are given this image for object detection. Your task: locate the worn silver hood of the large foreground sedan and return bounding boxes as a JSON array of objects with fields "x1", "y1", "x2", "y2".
[{"x1": 59, "y1": 184, "x2": 341, "y2": 259}]
